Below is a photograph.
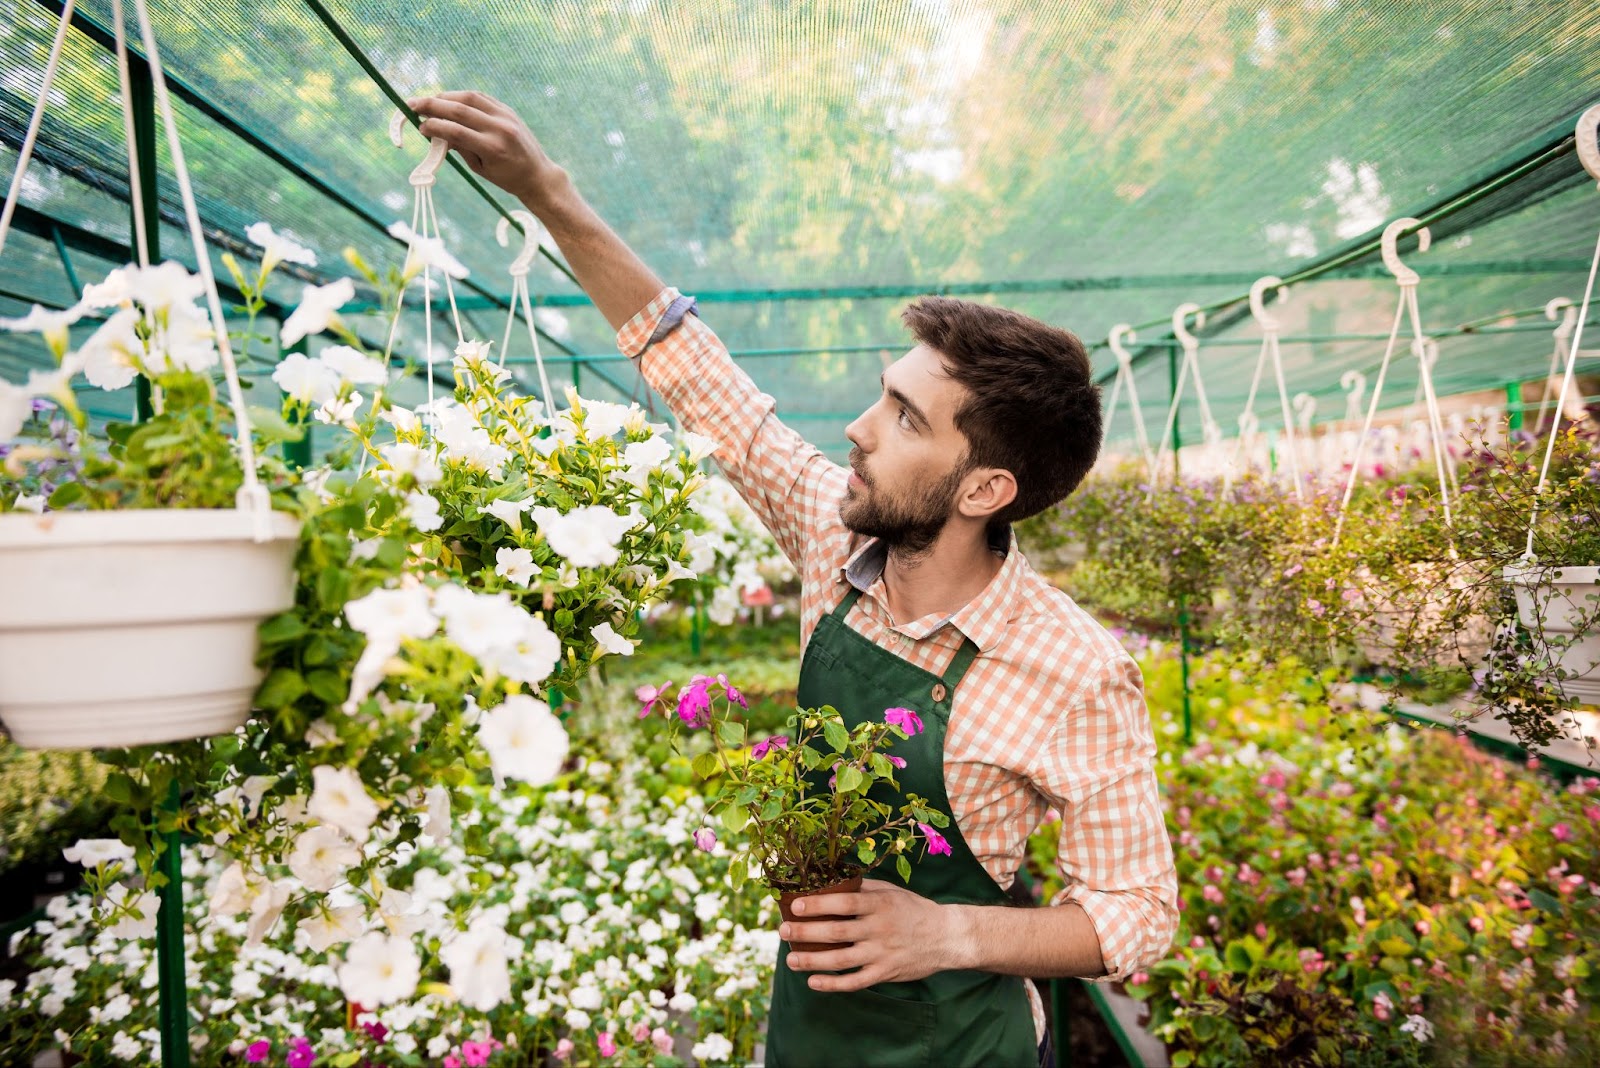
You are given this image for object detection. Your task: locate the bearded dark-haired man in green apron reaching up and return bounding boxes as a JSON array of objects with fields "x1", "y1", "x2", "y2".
[{"x1": 411, "y1": 93, "x2": 1178, "y2": 1068}]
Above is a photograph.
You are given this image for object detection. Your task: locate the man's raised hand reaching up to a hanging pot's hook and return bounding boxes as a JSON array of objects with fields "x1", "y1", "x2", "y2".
[{"x1": 406, "y1": 91, "x2": 566, "y2": 216}]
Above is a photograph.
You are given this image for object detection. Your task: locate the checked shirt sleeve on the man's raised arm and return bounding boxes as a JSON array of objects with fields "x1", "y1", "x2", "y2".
[{"x1": 616, "y1": 286, "x2": 848, "y2": 569}]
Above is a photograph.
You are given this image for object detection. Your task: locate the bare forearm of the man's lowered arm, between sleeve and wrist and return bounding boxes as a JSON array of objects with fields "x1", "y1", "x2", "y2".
[{"x1": 944, "y1": 903, "x2": 1106, "y2": 978}]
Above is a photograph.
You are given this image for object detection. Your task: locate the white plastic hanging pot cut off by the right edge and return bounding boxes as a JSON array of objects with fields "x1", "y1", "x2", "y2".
[{"x1": 1506, "y1": 566, "x2": 1600, "y2": 705}]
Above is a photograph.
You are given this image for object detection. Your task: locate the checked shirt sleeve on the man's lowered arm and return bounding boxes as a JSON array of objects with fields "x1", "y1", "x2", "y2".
[{"x1": 1035, "y1": 657, "x2": 1178, "y2": 980}]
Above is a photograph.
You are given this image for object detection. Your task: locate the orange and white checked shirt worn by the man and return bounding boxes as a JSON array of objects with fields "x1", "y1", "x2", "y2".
[{"x1": 618, "y1": 288, "x2": 1178, "y2": 1022}]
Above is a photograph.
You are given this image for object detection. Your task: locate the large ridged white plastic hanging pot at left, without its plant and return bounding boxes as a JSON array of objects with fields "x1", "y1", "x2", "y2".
[{"x1": 0, "y1": 508, "x2": 301, "y2": 748}]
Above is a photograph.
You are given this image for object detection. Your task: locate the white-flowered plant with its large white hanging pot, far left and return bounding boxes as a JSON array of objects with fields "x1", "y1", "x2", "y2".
[{"x1": 0, "y1": 255, "x2": 301, "y2": 748}]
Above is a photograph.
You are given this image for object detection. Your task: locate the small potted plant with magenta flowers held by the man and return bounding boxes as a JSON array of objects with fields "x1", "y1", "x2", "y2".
[{"x1": 640, "y1": 675, "x2": 950, "y2": 950}]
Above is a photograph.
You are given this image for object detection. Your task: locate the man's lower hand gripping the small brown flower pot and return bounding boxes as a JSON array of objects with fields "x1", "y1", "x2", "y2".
[{"x1": 778, "y1": 879, "x2": 965, "y2": 991}]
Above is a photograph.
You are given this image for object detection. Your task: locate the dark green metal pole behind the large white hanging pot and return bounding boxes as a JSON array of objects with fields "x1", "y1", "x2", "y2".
[{"x1": 128, "y1": 56, "x2": 189, "y2": 1068}]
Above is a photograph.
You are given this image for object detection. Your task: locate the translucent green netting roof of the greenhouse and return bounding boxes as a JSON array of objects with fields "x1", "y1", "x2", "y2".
[{"x1": 0, "y1": 0, "x2": 1600, "y2": 456}]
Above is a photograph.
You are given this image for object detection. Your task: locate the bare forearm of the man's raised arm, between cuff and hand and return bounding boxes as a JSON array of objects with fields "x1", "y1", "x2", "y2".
[{"x1": 523, "y1": 171, "x2": 666, "y2": 329}]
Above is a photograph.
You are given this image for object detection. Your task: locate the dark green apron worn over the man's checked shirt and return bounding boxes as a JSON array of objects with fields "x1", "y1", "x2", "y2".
[{"x1": 766, "y1": 588, "x2": 1038, "y2": 1068}]
